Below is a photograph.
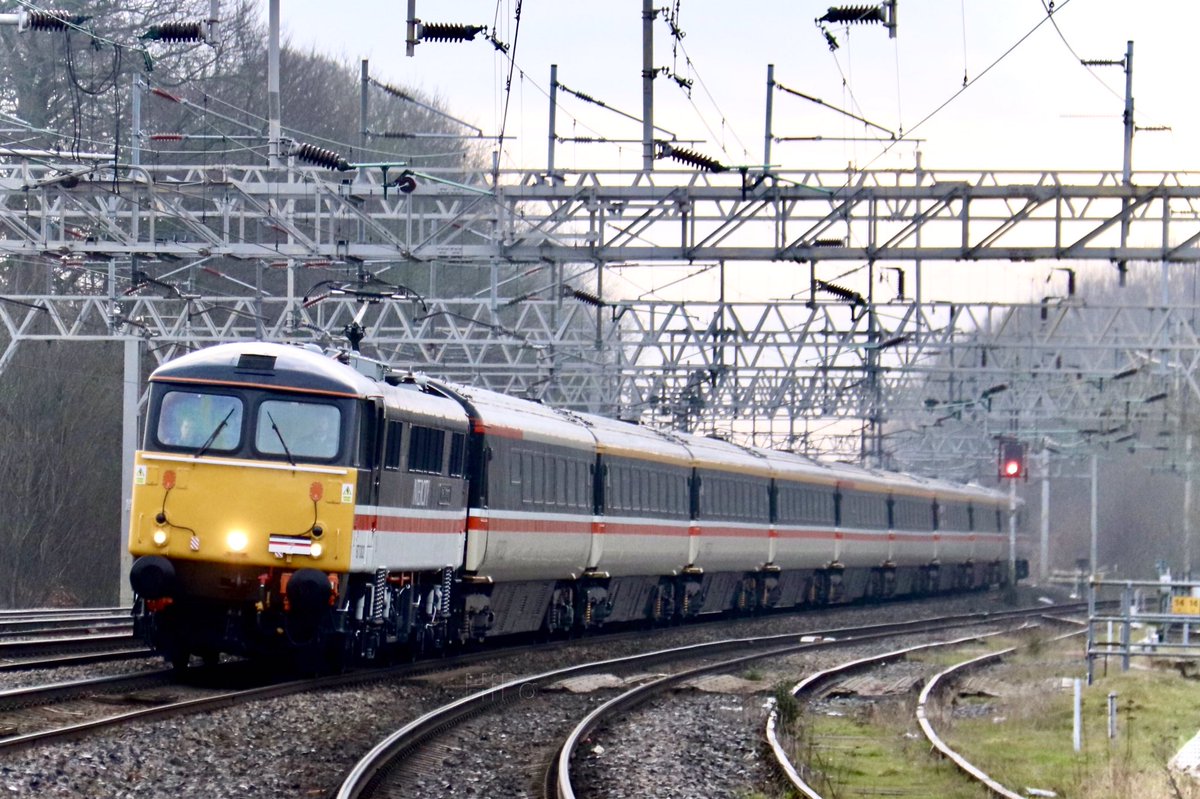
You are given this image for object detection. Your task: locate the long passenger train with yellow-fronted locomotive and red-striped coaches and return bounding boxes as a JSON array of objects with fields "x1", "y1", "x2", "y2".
[{"x1": 128, "y1": 342, "x2": 1027, "y2": 667}]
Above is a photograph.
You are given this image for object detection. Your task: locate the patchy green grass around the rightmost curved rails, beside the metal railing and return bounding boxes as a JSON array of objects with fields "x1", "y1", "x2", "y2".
[{"x1": 775, "y1": 638, "x2": 1200, "y2": 799}]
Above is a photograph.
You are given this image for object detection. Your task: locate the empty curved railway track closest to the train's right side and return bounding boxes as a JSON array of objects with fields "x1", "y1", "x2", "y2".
[{"x1": 336, "y1": 599, "x2": 1089, "y2": 799}]
